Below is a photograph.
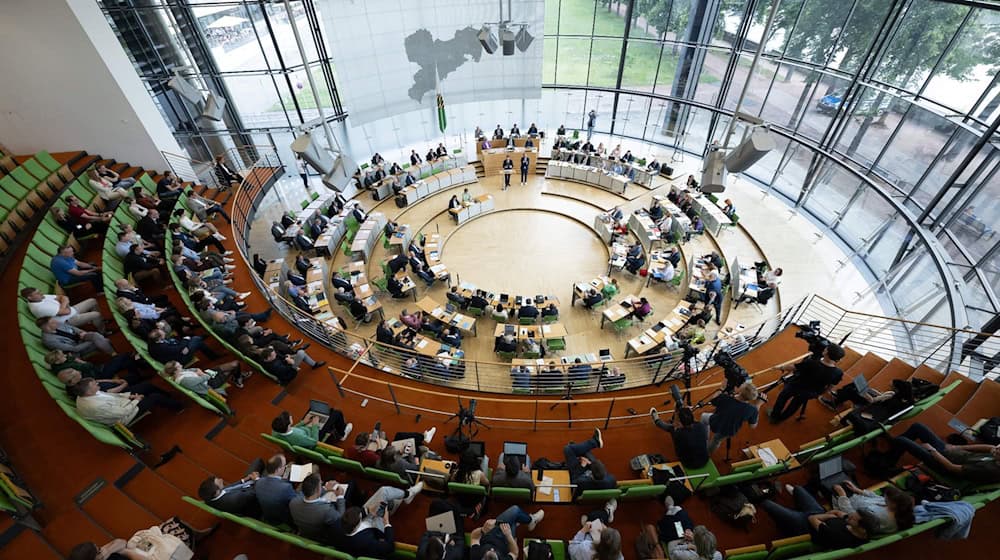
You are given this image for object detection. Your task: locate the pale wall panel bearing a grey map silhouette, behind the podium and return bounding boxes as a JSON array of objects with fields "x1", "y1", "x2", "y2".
[{"x1": 320, "y1": 0, "x2": 545, "y2": 126}]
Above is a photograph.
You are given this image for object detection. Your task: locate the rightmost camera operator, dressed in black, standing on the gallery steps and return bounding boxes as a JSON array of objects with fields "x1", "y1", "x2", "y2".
[{"x1": 770, "y1": 343, "x2": 844, "y2": 424}]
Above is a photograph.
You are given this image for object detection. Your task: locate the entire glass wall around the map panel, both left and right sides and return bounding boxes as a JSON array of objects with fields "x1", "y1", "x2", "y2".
[{"x1": 95, "y1": 0, "x2": 1000, "y2": 346}]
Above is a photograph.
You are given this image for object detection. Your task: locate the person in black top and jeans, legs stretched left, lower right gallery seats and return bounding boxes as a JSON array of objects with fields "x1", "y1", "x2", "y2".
[{"x1": 759, "y1": 485, "x2": 877, "y2": 549}]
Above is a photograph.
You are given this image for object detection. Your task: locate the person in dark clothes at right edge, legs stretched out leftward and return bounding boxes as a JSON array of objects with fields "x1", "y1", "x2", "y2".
[{"x1": 892, "y1": 422, "x2": 1000, "y2": 484}]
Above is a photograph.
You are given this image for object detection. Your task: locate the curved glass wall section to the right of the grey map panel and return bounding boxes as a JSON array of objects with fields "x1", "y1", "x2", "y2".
[{"x1": 543, "y1": 0, "x2": 1000, "y2": 344}]
